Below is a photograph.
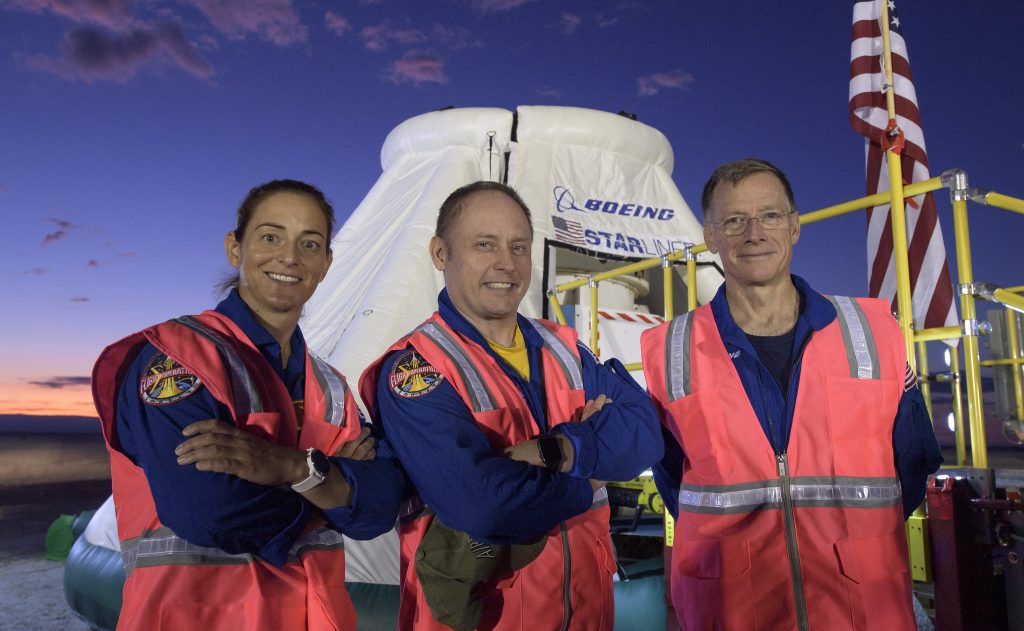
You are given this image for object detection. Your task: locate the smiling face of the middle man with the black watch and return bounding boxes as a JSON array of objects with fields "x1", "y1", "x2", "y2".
[{"x1": 430, "y1": 191, "x2": 532, "y2": 343}]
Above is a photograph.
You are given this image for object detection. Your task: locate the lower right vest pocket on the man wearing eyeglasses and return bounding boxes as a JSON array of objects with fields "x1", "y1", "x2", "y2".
[{"x1": 835, "y1": 533, "x2": 915, "y2": 629}]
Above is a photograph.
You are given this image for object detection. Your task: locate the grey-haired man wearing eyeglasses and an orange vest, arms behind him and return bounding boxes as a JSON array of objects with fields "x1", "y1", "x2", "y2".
[{"x1": 642, "y1": 159, "x2": 942, "y2": 630}]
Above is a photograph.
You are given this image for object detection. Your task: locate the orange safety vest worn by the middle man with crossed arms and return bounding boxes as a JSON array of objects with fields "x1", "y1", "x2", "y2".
[{"x1": 359, "y1": 312, "x2": 616, "y2": 631}]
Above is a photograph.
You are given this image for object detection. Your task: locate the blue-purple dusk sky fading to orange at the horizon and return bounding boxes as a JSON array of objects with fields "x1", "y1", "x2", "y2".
[{"x1": 0, "y1": 0, "x2": 1024, "y2": 415}]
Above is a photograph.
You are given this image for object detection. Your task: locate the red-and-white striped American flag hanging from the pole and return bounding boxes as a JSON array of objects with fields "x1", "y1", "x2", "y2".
[{"x1": 850, "y1": 0, "x2": 956, "y2": 329}]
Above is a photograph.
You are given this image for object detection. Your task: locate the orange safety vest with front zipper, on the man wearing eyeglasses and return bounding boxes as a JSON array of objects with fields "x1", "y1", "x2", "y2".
[{"x1": 641, "y1": 296, "x2": 916, "y2": 631}]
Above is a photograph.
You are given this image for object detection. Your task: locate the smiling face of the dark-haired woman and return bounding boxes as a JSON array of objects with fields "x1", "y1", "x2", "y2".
[{"x1": 224, "y1": 193, "x2": 332, "y2": 329}]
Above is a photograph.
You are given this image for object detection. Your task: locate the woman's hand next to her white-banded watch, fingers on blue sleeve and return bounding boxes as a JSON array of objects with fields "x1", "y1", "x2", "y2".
[{"x1": 174, "y1": 419, "x2": 309, "y2": 487}]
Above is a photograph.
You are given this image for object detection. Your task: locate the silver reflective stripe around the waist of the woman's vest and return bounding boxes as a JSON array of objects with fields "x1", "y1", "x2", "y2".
[{"x1": 121, "y1": 527, "x2": 345, "y2": 576}]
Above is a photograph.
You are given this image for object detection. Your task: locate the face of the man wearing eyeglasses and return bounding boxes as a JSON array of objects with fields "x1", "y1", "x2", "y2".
[{"x1": 703, "y1": 172, "x2": 800, "y2": 289}]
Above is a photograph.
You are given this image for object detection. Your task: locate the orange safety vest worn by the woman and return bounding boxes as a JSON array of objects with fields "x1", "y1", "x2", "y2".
[{"x1": 92, "y1": 311, "x2": 359, "y2": 631}]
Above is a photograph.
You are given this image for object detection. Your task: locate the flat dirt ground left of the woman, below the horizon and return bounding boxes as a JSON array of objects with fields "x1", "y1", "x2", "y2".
[{"x1": 0, "y1": 433, "x2": 111, "y2": 631}]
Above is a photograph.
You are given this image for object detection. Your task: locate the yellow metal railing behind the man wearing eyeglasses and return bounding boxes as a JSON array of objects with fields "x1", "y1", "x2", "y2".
[{"x1": 548, "y1": 171, "x2": 1024, "y2": 581}]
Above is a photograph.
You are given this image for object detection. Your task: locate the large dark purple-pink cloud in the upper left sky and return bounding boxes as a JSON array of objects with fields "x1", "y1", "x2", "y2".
[{"x1": 26, "y1": 23, "x2": 215, "y2": 83}]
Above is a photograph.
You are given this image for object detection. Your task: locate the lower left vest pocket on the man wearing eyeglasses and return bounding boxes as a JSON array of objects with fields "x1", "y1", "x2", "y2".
[{"x1": 672, "y1": 538, "x2": 756, "y2": 631}]
